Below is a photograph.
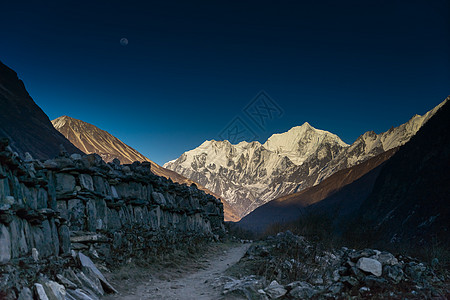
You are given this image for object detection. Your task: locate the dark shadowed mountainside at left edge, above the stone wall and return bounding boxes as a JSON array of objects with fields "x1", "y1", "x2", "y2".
[{"x1": 0, "y1": 62, "x2": 82, "y2": 159}]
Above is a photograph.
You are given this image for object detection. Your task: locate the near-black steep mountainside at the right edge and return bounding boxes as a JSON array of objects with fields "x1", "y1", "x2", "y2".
[{"x1": 346, "y1": 97, "x2": 450, "y2": 244}]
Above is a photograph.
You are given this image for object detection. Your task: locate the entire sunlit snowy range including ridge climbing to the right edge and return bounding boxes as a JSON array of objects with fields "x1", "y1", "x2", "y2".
[{"x1": 164, "y1": 101, "x2": 445, "y2": 218}]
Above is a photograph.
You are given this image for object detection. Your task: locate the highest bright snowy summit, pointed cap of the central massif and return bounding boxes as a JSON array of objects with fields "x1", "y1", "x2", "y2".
[{"x1": 263, "y1": 122, "x2": 348, "y2": 165}]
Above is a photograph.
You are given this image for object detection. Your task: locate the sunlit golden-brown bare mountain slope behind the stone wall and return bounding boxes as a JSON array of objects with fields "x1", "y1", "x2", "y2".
[{"x1": 52, "y1": 116, "x2": 238, "y2": 221}]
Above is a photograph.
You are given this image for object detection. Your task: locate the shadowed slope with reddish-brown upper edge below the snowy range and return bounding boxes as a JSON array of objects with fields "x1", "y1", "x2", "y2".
[{"x1": 237, "y1": 148, "x2": 398, "y2": 233}]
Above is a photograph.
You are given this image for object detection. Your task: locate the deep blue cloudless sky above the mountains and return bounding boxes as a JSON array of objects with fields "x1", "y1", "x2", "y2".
[{"x1": 0, "y1": 0, "x2": 450, "y2": 164}]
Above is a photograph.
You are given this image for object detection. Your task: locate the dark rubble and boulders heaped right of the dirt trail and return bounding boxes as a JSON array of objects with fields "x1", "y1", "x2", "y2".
[{"x1": 218, "y1": 231, "x2": 450, "y2": 299}]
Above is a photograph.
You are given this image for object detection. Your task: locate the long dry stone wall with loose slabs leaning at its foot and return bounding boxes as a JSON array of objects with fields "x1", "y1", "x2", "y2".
[{"x1": 0, "y1": 139, "x2": 225, "y2": 299}]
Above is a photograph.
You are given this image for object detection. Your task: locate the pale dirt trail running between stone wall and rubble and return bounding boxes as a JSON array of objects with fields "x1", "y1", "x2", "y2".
[{"x1": 105, "y1": 244, "x2": 250, "y2": 300}]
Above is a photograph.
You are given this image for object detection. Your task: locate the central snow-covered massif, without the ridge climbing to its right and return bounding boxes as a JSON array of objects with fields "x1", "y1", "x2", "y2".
[{"x1": 164, "y1": 123, "x2": 348, "y2": 217}]
